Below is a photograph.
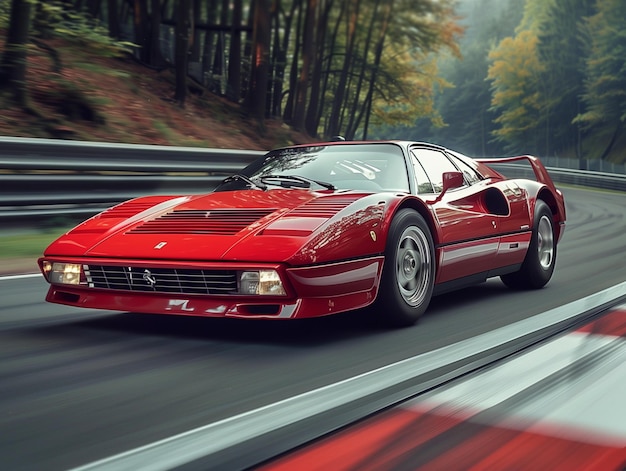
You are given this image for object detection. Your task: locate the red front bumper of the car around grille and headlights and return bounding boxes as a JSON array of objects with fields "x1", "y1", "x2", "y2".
[{"x1": 41, "y1": 256, "x2": 383, "y2": 319}]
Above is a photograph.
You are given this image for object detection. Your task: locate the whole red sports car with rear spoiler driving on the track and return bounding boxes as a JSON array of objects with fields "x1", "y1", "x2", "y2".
[{"x1": 39, "y1": 141, "x2": 565, "y2": 326}]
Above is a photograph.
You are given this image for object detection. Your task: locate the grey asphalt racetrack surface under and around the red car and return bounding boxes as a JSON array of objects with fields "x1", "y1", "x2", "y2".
[{"x1": 0, "y1": 188, "x2": 626, "y2": 470}]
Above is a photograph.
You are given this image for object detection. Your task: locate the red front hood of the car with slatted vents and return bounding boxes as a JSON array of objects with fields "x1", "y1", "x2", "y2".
[{"x1": 46, "y1": 189, "x2": 385, "y2": 264}]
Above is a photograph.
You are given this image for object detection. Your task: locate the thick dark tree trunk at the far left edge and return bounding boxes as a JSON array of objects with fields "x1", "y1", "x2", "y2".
[{"x1": 0, "y1": 0, "x2": 31, "y2": 107}]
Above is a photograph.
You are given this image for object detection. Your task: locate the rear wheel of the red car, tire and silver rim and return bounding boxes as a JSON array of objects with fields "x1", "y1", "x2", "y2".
[{"x1": 500, "y1": 200, "x2": 556, "y2": 289}]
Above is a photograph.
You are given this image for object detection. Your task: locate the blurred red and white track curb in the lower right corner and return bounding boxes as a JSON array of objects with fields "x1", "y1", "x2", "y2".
[{"x1": 260, "y1": 304, "x2": 626, "y2": 471}]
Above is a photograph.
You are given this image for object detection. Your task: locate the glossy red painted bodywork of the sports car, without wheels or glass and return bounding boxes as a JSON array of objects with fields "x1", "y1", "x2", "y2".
[{"x1": 40, "y1": 142, "x2": 565, "y2": 317}]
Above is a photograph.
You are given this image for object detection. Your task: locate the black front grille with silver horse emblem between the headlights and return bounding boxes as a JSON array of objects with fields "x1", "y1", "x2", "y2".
[{"x1": 84, "y1": 265, "x2": 237, "y2": 294}]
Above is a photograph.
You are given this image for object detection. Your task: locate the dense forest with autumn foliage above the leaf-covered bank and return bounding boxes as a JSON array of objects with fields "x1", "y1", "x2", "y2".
[{"x1": 0, "y1": 0, "x2": 626, "y2": 162}]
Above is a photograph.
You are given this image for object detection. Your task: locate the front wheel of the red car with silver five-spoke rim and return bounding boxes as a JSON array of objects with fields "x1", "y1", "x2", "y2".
[{"x1": 373, "y1": 209, "x2": 435, "y2": 327}]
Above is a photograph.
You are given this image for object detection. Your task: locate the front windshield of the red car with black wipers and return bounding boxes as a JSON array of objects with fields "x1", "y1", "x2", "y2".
[{"x1": 215, "y1": 144, "x2": 409, "y2": 192}]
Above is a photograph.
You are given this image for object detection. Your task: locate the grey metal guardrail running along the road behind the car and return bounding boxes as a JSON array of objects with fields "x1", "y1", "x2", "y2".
[{"x1": 0, "y1": 137, "x2": 626, "y2": 221}]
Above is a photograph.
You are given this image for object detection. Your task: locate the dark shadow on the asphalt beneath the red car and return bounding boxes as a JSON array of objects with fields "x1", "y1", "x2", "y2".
[{"x1": 30, "y1": 282, "x2": 511, "y2": 347}]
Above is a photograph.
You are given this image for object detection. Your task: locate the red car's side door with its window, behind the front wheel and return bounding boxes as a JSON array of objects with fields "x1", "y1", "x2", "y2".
[{"x1": 411, "y1": 147, "x2": 499, "y2": 283}]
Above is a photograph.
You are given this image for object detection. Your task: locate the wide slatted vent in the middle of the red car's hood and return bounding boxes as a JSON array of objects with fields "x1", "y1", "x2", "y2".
[{"x1": 129, "y1": 208, "x2": 276, "y2": 235}]
